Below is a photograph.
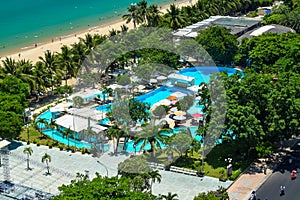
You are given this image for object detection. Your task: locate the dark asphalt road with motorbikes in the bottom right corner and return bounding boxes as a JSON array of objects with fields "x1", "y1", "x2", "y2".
[{"x1": 256, "y1": 145, "x2": 300, "y2": 200}]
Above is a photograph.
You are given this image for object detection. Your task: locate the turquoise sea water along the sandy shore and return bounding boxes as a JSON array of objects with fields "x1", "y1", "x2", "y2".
[{"x1": 0, "y1": 0, "x2": 174, "y2": 54}]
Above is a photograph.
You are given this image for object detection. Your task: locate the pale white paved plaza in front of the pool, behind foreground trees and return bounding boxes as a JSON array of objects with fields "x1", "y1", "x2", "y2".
[{"x1": 0, "y1": 143, "x2": 232, "y2": 200}]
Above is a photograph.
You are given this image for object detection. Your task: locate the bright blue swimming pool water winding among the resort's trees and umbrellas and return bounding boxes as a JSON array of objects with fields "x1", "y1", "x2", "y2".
[{"x1": 38, "y1": 67, "x2": 240, "y2": 152}]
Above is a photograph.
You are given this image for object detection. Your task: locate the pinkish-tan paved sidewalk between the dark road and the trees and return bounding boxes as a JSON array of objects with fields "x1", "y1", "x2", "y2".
[{"x1": 227, "y1": 138, "x2": 299, "y2": 200}]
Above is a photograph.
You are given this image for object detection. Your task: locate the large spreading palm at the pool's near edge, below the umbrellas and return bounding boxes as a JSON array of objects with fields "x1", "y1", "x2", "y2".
[{"x1": 134, "y1": 124, "x2": 170, "y2": 158}]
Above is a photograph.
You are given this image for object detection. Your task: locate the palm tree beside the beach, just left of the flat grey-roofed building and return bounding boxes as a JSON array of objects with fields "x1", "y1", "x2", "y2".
[{"x1": 166, "y1": 4, "x2": 185, "y2": 30}]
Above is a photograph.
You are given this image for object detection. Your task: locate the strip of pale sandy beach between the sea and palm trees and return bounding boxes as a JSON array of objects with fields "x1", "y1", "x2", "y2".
[{"x1": 1, "y1": 0, "x2": 196, "y2": 64}]
